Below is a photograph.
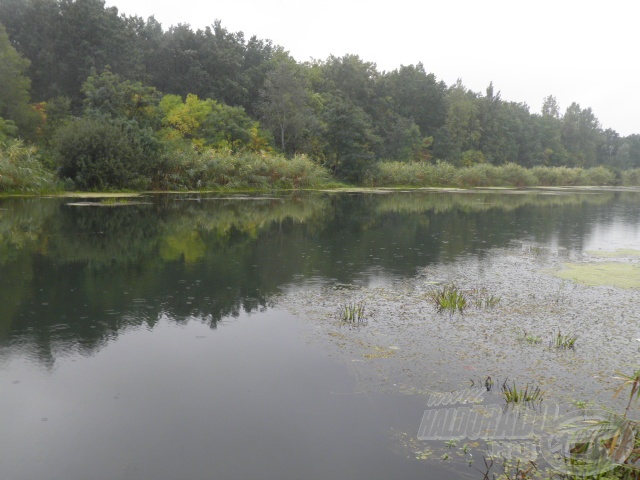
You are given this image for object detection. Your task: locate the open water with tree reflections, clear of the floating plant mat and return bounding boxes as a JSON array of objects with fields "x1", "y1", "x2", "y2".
[{"x1": 0, "y1": 191, "x2": 640, "y2": 480}]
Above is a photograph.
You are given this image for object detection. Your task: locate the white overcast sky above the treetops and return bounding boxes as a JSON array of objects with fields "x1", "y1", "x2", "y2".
[{"x1": 106, "y1": 0, "x2": 640, "y2": 135}]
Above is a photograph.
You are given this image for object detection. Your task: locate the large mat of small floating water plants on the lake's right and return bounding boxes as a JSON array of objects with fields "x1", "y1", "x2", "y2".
[{"x1": 278, "y1": 245, "x2": 640, "y2": 408}]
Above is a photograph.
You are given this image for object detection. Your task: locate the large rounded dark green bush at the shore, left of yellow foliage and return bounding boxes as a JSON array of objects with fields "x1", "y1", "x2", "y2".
[{"x1": 54, "y1": 117, "x2": 161, "y2": 190}]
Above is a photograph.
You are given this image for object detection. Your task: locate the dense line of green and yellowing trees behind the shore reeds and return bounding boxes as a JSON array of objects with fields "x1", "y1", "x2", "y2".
[{"x1": 0, "y1": 0, "x2": 640, "y2": 188}]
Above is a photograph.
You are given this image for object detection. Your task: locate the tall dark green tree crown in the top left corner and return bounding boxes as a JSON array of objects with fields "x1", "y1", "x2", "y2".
[{"x1": 0, "y1": 0, "x2": 141, "y2": 106}]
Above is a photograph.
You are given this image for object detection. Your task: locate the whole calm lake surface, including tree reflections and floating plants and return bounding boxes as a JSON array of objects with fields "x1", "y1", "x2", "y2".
[{"x1": 0, "y1": 189, "x2": 640, "y2": 480}]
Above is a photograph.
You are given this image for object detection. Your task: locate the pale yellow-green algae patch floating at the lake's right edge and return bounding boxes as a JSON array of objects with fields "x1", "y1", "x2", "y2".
[{"x1": 554, "y1": 262, "x2": 640, "y2": 288}]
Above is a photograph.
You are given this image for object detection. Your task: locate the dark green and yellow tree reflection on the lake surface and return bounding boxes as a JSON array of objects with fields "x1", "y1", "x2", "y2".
[{"x1": 0, "y1": 193, "x2": 637, "y2": 363}]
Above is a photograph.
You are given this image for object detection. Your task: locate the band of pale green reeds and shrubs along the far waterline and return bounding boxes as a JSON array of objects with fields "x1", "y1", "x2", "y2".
[{"x1": 0, "y1": 141, "x2": 640, "y2": 194}]
